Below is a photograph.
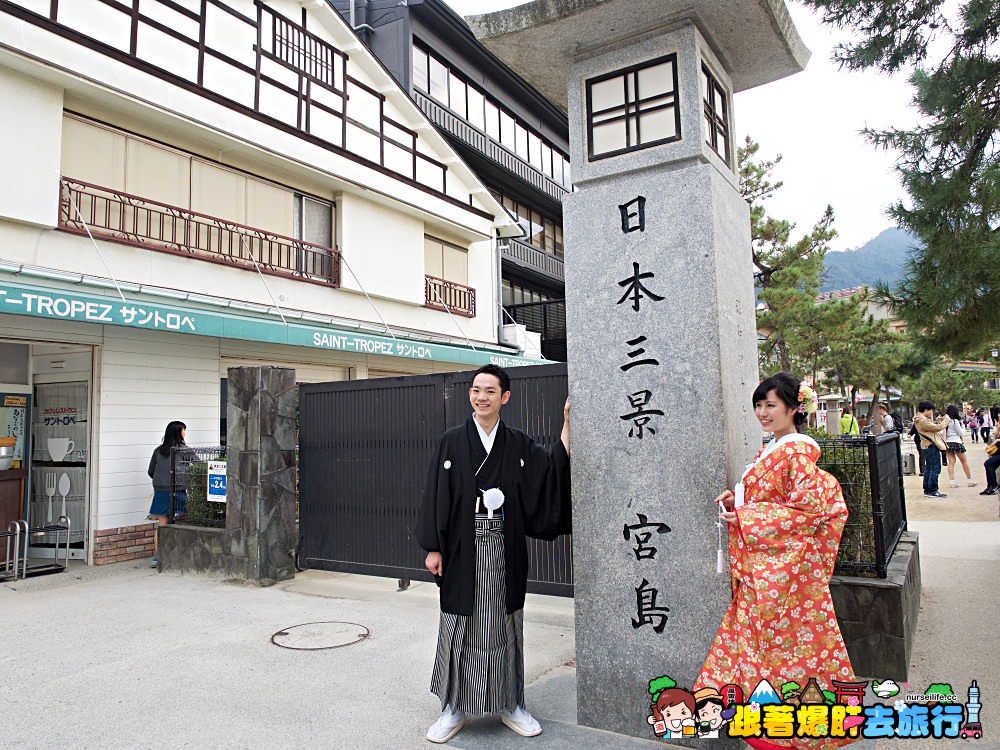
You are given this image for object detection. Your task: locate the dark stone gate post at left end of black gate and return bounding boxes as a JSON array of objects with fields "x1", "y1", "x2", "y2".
[{"x1": 225, "y1": 367, "x2": 297, "y2": 581}]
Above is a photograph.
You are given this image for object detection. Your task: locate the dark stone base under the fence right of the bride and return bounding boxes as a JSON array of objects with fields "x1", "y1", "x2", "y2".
[{"x1": 830, "y1": 531, "x2": 920, "y2": 684}]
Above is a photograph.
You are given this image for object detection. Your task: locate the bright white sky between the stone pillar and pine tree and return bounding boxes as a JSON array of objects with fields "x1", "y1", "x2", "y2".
[{"x1": 446, "y1": 0, "x2": 916, "y2": 250}]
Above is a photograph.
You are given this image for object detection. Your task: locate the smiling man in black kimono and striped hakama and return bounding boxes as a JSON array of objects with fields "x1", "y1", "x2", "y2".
[{"x1": 417, "y1": 365, "x2": 571, "y2": 743}]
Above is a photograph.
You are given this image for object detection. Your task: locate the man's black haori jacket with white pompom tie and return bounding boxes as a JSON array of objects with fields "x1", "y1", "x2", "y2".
[{"x1": 417, "y1": 417, "x2": 572, "y2": 615}]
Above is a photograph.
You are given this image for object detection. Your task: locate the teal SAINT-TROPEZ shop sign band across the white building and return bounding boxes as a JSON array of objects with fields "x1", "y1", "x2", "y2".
[{"x1": 0, "y1": 283, "x2": 548, "y2": 367}]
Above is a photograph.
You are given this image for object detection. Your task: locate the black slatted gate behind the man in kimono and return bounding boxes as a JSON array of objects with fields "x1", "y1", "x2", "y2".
[{"x1": 299, "y1": 364, "x2": 573, "y2": 596}]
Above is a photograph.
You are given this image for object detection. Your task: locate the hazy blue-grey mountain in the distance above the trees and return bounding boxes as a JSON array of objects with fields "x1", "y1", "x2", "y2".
[{"x1": 819, "y1": 227, "x2": 917, "y2": 292}]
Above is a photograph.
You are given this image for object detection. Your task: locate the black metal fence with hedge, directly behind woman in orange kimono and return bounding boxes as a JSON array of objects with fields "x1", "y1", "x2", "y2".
[{"x1": 817, "y1": 432, "x2": 906, "y2": 578}]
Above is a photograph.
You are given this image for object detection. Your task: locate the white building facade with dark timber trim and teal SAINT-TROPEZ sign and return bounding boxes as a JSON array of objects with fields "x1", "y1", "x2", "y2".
[{"x1": 0, "y1": 0, "x2": 538, "y2": 563}]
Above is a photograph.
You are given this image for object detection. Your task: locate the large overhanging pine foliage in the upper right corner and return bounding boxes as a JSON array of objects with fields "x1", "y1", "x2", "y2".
[{"x1": 803, "y1": 0, "x2": 1000, "y2": 357}]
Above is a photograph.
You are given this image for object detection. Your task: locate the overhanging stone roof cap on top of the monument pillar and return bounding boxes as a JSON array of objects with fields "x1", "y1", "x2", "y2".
[{"x1": 466, "y1": 0, "x2": 810, "y2": 109}]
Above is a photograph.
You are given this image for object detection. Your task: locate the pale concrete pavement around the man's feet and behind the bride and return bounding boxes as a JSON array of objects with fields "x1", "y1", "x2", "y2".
[{"x1": 0, "y1": 445, "x2": 1000, "y2": 750}]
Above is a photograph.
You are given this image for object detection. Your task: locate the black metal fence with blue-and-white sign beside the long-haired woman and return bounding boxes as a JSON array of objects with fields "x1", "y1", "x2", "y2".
[{"x1": 167, "y1": 445, "x2": 226, "y2": 528}]
